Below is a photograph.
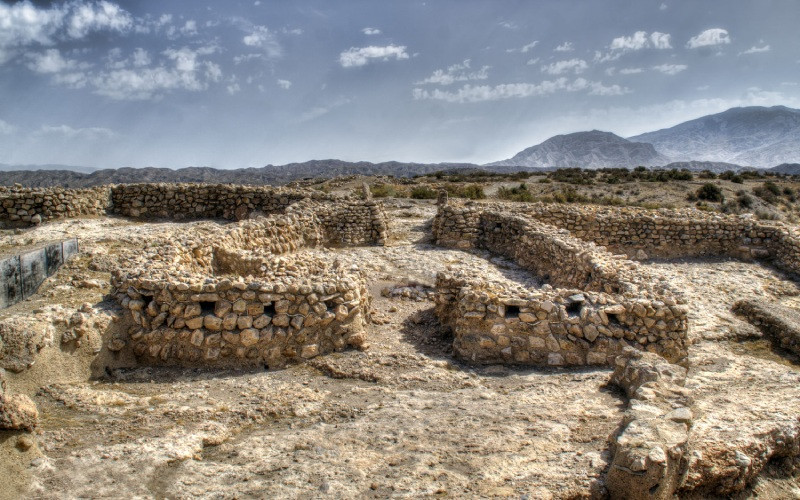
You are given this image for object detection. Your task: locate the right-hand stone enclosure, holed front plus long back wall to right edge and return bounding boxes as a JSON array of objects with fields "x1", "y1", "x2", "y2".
[{"x1": 433, "y1": 199, "x2": 800, "y2": 366}]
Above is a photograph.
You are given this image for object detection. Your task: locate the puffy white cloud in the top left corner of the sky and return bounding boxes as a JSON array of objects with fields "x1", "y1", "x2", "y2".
[{"x1": 0, "y1": 0, "x2": 133, "y2": 64}]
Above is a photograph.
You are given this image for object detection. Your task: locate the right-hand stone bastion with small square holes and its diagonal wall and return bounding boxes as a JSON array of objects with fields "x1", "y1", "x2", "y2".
[{"x1": 434, "y1": 205, "x2": 688, "y2": 366}]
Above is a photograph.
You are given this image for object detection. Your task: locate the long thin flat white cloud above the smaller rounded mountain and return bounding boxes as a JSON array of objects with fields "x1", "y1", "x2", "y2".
[{"x1": 412, "y1": 77, "x2": 630, "y2": 103}]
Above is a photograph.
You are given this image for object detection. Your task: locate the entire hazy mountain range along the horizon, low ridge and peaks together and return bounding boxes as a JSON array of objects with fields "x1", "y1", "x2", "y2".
[{"x1": 0, "y1": 106, "x2": 800, "y2": 187}]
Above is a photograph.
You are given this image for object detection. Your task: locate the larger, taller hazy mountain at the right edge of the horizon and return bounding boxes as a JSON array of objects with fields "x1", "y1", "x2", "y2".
[{"x1": 628, "y1": 106, "x2": 800, "y2": 168}]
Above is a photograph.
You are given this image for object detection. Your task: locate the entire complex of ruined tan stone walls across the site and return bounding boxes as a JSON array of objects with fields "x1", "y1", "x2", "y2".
[{"x1": 0, "y1": 184, "x2": 800, "y2": 498}]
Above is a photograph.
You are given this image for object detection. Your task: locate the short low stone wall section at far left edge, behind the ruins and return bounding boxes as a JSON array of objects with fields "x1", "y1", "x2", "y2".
[{"x1": 0, "y1": 186, "x2": 110, "y2": 226}]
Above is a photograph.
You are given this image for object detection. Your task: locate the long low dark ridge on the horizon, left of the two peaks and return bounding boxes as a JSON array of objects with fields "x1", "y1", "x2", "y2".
[{"x1": 0, "y1": 160, "x2": 518, "y2": 188}]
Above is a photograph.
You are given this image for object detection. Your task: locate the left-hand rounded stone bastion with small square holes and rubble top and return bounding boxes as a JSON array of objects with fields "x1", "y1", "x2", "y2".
[{"x1": 108, "y1": 202, "x2": 385, "y2": 367}]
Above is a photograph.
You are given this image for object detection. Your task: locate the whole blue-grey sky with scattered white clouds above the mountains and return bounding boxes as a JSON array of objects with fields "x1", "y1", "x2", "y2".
[{"x1": 0, "y1": 0, "x2": 800, "y2": 168}]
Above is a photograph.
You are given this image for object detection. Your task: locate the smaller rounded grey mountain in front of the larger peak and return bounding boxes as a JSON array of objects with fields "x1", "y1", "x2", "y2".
[{"x1": 489, "y1": 130, "x2": 670, "y2": 168}]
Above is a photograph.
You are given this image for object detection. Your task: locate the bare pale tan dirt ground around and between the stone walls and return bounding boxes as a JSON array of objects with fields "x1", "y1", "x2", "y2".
[{"x1": 0, "y1": 200, "x2": 800, "y2": 499}]
